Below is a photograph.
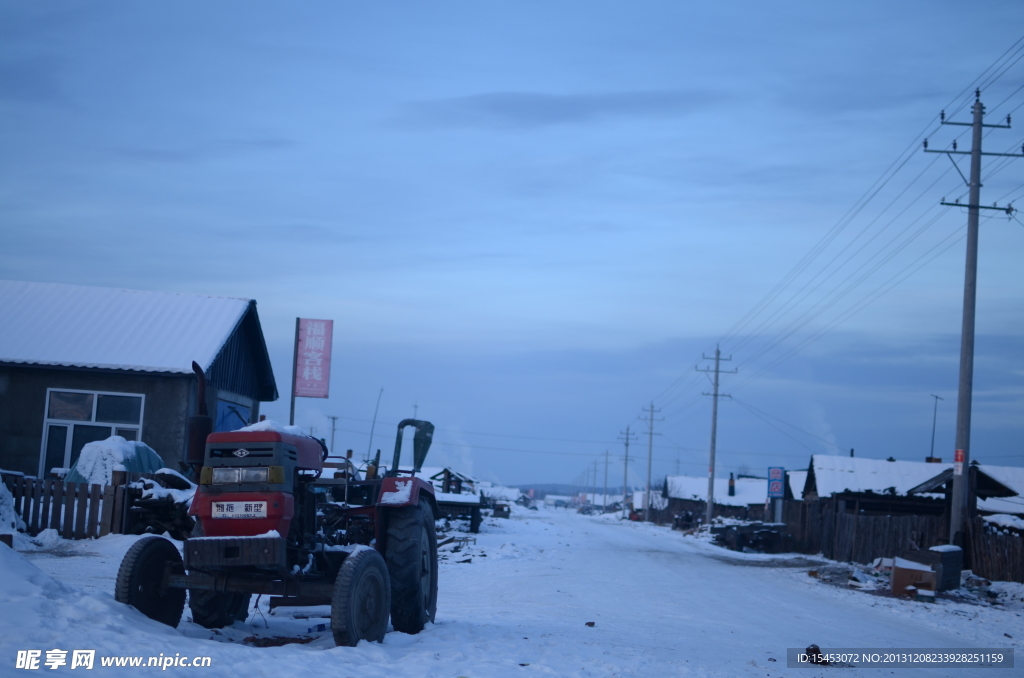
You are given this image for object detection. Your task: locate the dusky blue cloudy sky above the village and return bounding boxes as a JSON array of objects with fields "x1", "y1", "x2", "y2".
[{"x1": 0, "y1": 1, "x2": 1024, "y2": 484}]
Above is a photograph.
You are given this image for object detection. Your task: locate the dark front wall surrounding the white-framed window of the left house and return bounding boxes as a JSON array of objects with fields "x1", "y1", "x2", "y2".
[{"x1": 0, "y1": 364, "x2": 196, "y2": 475}]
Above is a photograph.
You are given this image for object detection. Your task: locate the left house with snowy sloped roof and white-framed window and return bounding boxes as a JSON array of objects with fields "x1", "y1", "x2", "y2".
[{"x1": 0, "y1": 281, "x2": 278, "y2": 476}]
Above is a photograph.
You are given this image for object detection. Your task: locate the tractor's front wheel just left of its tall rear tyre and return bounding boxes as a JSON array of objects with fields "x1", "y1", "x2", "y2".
[{"x1": 331, "y1": 549, "x2": 391, "y2": 647}]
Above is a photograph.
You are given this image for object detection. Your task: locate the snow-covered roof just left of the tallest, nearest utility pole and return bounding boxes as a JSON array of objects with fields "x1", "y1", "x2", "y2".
[{"x1": 811, "y1": 455, "x2": 952, "y2": 497}]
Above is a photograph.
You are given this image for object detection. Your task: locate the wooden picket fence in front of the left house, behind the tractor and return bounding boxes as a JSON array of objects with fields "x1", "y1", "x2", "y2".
[{"x1": 2, "y1": 472, "x2": 141, "y2": 539}]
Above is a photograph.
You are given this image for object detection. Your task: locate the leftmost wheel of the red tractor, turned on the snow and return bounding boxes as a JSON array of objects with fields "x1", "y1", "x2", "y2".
[{"x1": 114, "y1": 537, "x2": 185, "y2": 628}]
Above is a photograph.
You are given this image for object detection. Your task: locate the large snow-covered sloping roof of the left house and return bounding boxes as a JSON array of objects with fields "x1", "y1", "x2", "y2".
[{"x1": 0, "y1": 281, "x2": 251, "y2": 373}]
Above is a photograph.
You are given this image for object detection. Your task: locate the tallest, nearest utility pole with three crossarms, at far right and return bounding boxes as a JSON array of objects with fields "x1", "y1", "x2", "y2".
[{"x1": 925, "y1": 89, "x2": 1024, "y2": 546}]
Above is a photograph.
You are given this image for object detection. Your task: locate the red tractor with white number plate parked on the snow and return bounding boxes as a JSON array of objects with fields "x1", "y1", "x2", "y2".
[{"x1": 115, "y1": 387, "x2": 438, "y2": 645}]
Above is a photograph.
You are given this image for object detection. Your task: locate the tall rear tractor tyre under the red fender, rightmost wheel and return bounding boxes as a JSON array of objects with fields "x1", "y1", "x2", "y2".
[{"x1": 386, "y1": 499, "x2": 437, "y2": 633}]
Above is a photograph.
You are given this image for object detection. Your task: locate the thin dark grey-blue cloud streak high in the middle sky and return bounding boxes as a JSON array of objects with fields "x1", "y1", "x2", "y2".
[{"x1": 399, "y1": 90, "x2": 726, "y2": 129}]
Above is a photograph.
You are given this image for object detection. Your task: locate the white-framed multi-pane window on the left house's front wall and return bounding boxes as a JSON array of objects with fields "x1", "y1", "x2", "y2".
[{"x1": 39, "y1": 388, "x2": 145, "y2": 477}]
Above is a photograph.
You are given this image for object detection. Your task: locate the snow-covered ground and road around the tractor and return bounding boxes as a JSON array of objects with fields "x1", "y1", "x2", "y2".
[{"x1": 0, "y1": 506, "x2": 1024, "y2": 678}]
